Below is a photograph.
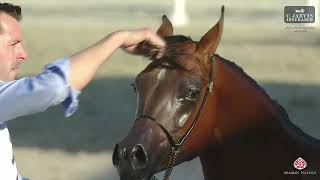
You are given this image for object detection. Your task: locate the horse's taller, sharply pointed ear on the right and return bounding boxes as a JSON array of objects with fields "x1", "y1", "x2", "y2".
[{"x1": 197, "y1": 6, "x2": 224, "y2": 56}]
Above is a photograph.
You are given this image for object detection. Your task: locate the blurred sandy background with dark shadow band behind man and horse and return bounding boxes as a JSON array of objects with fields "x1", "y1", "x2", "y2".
[{"x1": 3, "y1": 0, "x2": 320, "y2": 180}]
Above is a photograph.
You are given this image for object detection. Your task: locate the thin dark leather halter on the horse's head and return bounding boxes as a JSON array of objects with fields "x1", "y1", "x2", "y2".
[{"x1": 135, "y1": 55, "x2": 215, "y2": 180}]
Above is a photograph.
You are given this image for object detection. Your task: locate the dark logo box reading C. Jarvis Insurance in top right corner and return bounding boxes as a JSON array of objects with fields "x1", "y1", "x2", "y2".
[{"x1": 284, "y1": 6, "x2": 315, "y2": 23}]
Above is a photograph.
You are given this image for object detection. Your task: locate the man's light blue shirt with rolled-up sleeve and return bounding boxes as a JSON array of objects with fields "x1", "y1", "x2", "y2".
[{"x1": 0, "y1": 59, "x2": 80, "y2": 180}]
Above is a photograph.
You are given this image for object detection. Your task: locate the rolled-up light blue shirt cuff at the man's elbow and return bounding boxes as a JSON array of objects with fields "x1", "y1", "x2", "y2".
[{"x1": 45, "y1": 58, "x2": 81, "y2": 117}]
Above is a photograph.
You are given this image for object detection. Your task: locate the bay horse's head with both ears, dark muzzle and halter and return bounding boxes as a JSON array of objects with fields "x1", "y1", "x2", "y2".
[{"x1": 113, "y1": 7, "x2": 224, "y2": 180}]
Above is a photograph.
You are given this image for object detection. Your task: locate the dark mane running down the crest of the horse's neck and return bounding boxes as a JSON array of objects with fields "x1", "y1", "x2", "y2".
[{"x1": 214, "y1": 54, "x2": 320, "y2": 150}]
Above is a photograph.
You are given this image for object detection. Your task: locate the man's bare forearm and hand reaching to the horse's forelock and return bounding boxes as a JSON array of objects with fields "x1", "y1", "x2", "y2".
[{"x1": 70, "y1": 29, "x2": 165, "y2": 90}]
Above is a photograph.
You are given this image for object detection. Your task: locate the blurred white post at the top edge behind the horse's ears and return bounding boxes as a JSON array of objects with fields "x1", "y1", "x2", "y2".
[{"x1": 171, "y1": 0, "x2": 189, "y2": 27}]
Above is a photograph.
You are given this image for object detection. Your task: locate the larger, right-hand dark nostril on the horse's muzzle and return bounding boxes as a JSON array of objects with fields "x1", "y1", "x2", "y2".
[{"x1": 130, "y1": 144, "x2": 148, "y2": 170}]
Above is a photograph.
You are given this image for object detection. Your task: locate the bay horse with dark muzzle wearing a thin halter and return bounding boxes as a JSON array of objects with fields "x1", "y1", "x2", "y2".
[{"x1": 112, "y1": 5, "x2": 320, "y2": 180}]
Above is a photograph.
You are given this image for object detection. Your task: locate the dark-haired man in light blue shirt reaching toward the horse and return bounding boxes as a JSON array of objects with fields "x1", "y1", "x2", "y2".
[{"x1": 0, "y1": 3, "x2": 165, "y2": 180}]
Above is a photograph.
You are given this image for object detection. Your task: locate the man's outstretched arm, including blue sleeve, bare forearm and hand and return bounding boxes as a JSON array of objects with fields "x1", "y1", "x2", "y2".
[{"x1": 0, "y1": 29, "x2": 165, "y2": 124}]
